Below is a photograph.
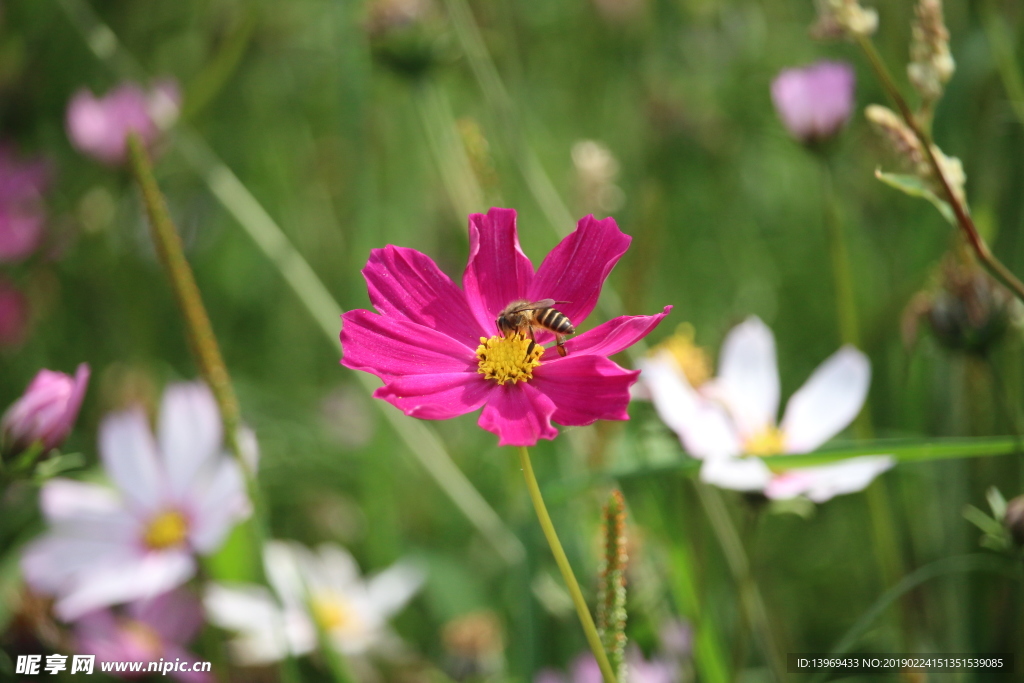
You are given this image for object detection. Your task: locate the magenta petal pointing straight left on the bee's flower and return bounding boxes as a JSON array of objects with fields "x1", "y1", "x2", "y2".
[{"x1": 341, "y1": 310, "x2": 477, "y2": 380}]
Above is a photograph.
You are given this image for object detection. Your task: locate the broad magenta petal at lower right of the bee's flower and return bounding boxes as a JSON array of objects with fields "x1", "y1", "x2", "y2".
[{"x1": 530, "y1": 355, "x2": 640, "y2": 426}]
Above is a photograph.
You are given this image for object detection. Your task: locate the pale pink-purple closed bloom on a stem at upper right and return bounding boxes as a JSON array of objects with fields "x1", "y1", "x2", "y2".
[{"x1": 771, "y1": 61, "x2": 855, "y2": 143}]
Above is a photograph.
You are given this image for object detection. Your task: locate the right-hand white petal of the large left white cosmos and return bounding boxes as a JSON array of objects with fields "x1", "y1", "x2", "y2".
[{"x1": 185, "y1": 456, "x2": 252, "y2": 555}]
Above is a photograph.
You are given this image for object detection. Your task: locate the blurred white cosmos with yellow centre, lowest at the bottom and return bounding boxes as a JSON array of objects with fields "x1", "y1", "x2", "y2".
[{"x1": 204, "y1": 541, "x2": 424, "y2": 666}]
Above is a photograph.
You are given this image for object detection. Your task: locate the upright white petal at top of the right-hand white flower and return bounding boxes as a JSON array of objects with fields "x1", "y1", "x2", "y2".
[{"x1": 712, "y1": 315, "x2": 779, "y2": 436}]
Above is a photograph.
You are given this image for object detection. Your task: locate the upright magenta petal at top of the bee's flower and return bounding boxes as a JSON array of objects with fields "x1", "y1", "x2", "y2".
[{"x1": 462, "y1": 209, "x2": 534, "y2": 334}]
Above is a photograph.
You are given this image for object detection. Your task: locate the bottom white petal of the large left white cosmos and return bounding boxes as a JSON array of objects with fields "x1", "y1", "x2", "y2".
[{"x1": 53, "y1": 550, "x2": 196, "y2": 621}]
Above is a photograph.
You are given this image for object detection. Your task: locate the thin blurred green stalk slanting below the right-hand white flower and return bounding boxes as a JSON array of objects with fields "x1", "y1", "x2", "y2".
[{"x1": 693, "y1": 481, "x2": 786, "y2": 683}]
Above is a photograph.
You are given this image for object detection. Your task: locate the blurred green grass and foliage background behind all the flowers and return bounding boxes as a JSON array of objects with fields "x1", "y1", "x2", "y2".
[{"x1": 0, "y1": 0, "x2": 1024, "y2": 681}]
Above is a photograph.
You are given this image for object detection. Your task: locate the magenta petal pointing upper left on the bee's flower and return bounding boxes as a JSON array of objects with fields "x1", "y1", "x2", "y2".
[{"x1": 362, "y1": 246, "x2": 485, "y2": 347}]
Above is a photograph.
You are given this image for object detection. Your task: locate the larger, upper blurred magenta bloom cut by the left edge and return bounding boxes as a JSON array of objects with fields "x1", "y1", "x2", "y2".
[{"x1": 0, "y1": 144, "x2": 50, "y2": 262}]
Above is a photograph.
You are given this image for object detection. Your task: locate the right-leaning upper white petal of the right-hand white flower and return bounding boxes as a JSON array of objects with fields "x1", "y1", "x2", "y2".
[{"x1": 782, "y1": 346, "x2": 871, "y2": 453}]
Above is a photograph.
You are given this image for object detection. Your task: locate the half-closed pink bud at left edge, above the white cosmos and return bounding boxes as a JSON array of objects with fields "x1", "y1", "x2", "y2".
[{"x1": 0, "y1": 362, "x2": 89, "y2": 453}]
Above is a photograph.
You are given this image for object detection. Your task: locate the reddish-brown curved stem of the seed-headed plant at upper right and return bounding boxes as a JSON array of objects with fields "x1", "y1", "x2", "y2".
[{"x1": 857, "y1": 36, "x2": 1024, "y2": 301}]
